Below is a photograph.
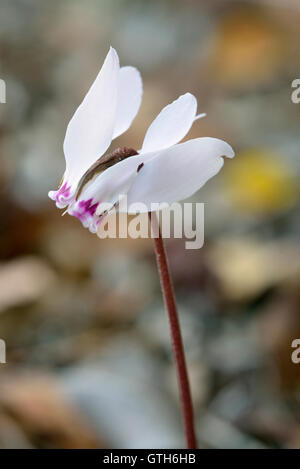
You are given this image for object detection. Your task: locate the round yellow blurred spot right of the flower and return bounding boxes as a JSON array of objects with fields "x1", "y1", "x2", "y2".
[{"x1": 225, "y1": 149, "x2": 296, "y2": 213}]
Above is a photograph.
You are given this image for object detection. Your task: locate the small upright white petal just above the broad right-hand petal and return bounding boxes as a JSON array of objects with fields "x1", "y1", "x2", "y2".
[{"x1": 141, "y1": 93, "x2": 197, "y2": 152}]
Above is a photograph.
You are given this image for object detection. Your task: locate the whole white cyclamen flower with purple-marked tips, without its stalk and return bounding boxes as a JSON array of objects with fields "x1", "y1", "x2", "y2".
[{"x1": 49, "y1": 48, "x2": 234, "y2": 233}]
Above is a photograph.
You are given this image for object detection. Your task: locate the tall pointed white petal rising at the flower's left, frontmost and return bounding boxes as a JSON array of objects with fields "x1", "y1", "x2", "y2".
[{"x1": 64, "y1": 48, "x2": 120, "y2": 184}]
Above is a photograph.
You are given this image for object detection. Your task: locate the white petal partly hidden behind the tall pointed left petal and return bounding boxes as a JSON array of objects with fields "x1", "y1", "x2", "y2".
[{"x1": 113, "y1": 67, "x2": 143, "y2": 138}]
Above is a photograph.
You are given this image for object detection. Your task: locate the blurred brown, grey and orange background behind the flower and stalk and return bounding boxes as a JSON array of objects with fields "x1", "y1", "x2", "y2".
[{"x1": 0, "y1": 0, "x2": 300, "y2": 448}]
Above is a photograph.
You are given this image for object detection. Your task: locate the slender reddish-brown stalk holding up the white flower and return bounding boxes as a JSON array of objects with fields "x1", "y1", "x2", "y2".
[{"x1": 149, "y1": 213, "x2": 197, "y2": 449}]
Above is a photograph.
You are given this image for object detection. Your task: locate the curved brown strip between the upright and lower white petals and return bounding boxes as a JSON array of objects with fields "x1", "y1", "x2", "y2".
[{"x1": 75, "y1": 147, "x2": 138, "y2": 200}]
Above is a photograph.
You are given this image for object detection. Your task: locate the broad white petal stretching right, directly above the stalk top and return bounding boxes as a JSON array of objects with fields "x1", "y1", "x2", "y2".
[{"x1": 127, "y1": 137, "x2": 234, "y2": 213}]
